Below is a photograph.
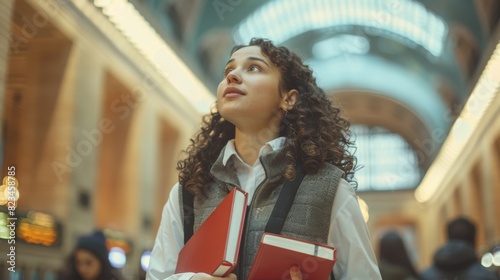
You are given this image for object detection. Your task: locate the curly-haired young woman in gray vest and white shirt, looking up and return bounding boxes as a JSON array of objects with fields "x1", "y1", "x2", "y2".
[{"x1": 147, "y1": 39, "x2": 381, "y2": 280}]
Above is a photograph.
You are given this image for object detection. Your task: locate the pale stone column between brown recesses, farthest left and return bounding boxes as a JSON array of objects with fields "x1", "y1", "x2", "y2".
[{"x1": 65, "y1": 42, "x2": 105, "y2": 255}]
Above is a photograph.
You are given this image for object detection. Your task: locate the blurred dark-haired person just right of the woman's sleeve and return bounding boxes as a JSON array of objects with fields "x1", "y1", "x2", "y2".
[{"x1": 379, "y1": 231, "x2": 419, "y2": 280}]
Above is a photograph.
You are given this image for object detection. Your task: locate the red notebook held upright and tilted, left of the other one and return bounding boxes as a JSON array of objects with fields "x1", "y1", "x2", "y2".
[{"x1": 175, "y1": 188, "x2": 248, "y2": 277}]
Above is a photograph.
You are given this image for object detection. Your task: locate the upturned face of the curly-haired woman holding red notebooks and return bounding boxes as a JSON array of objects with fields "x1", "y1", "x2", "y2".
[{"x1": 217, "y1": 46, "x2": 285, "y2": 130}]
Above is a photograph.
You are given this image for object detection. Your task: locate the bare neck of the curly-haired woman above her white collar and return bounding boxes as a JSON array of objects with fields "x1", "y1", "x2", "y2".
[{"x1": 234, "y1": 129, "x2": 278, "y2": 166}]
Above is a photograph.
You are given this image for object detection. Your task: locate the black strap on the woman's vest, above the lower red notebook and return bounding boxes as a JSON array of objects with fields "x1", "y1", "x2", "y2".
[{"x1": 264, "y1": 164, "x2": 304, "y2": 234}]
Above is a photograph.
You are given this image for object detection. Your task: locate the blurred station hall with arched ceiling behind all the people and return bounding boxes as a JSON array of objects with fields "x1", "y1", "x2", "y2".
[{"x1": 0, "y1": 0, "x2": 500, "y2": 280}]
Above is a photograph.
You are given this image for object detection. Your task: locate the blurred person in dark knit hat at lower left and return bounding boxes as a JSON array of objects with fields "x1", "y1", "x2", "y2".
[{"x1": 59, "y1": 231, "x2": 124, "y2": 280}]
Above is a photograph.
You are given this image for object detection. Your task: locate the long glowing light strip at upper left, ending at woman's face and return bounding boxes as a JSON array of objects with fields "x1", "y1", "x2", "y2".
[{"x1": 94, "y1": 0, "x2": 215, "y2": 114}]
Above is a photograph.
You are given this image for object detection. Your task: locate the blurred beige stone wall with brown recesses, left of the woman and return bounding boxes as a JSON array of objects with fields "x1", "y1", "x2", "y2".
[{"x1": 0, "y1": 0, "x2": 202, "y2": 279}]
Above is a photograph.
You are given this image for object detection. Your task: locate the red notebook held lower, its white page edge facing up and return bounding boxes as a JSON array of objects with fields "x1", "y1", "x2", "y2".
[{"x1": 248, "y1": 232, "x2": 337, "y2": 280}]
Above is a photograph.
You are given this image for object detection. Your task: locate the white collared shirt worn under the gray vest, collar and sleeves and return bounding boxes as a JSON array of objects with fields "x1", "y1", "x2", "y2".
[{"x1": 146, "y1": 137, "x2": 382, "y2": 280}]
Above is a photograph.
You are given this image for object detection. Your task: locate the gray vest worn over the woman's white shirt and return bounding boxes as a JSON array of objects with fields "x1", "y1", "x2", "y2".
[{"x1": 179, "y1": 149, "x2": 343, "y2": 279}]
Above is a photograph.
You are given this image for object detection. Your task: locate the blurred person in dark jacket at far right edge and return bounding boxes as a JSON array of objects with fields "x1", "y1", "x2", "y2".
[{"x1": 421, "y1": 217, "x2": 498, "y2": 280}]
